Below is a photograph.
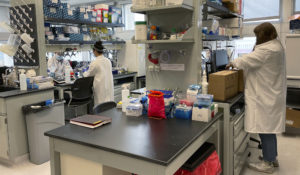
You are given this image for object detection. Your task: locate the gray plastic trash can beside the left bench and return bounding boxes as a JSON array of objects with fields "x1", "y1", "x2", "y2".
[{"x1": 23, "y1": 101, "x2": 65, "y2": 165}]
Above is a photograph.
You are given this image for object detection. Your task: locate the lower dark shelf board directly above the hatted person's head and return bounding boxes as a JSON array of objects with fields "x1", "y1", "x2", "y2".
[{"x1": 46, "y1": 41, "x2": 125, "y2": 45}]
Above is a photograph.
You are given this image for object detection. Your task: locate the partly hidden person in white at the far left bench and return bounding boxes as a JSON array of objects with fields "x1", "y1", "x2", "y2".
[{"x1": 48, "y1": 53, "x2": 71, "y2": 78}]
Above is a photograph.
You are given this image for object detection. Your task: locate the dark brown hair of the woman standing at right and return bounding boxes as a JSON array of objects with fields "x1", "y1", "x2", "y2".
[{"x1": 254, "y1": 22, "x2": 278, "y2": 45}]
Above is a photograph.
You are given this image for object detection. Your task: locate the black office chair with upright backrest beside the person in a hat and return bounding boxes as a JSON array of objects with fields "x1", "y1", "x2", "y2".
[{"x1": 65, "y1": 77, "x2": 94, "y2": 117}]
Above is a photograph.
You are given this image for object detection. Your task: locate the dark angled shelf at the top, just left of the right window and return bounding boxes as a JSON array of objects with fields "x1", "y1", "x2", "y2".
[{"x1": 203, "y1": 1, "x2": 243, "y2": 18}]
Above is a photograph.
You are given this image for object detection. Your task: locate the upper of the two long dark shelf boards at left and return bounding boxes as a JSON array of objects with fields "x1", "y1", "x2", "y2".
[{"x1": 45, "y1": 18, "x2": 125, "y2": 27}]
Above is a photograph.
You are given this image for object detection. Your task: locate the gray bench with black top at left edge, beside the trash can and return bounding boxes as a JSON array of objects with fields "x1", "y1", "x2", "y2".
[{"x1": 0, "y1": 88, "x2": 54, "y2": 162}]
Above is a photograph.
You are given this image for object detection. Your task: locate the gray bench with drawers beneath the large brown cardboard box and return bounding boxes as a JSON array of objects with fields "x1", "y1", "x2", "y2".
[{"x1": 216, "y1": 93, "x2": 250, "y2": 175}]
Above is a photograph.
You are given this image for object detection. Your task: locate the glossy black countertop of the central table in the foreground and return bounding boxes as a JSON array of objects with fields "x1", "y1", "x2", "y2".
[{"x1": 45, "y1": 109, "x2": 222, "y2": 165}]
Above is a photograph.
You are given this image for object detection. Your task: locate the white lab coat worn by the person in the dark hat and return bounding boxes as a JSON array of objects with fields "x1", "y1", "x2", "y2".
[{"x1": 83, "y1": 55, "x2": 114, "y2": 106}]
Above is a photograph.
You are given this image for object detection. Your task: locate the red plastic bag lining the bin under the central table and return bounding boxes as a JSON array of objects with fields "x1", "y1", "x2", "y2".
[{"x1": 174, "y1": 151, "x2": 222, "y2": 175}]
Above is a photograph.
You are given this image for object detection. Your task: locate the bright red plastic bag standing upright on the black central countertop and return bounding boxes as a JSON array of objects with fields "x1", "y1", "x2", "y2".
[{"x1": 148, "y1": 91, "x2": 166, "y2": 119}]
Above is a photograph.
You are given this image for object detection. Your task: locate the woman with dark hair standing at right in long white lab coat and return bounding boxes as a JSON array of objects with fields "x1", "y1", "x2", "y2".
[{"x1": 227, "y1": 23, "x2": 287, "y2": 173}]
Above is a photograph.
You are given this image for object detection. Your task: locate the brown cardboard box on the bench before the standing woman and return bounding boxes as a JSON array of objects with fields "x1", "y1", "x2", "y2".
[{"x1": 208, "y1": 71, "x2": 238, "y2": 101}]
